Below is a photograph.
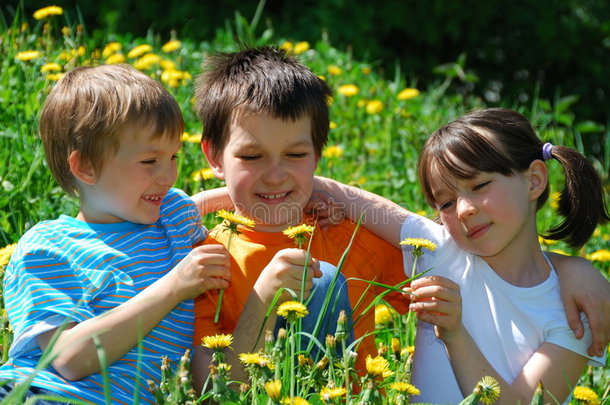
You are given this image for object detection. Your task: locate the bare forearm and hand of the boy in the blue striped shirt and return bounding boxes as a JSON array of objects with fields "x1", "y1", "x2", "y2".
[{"x1": 38, "y1": 245, "x2": 230, "y2": 380}]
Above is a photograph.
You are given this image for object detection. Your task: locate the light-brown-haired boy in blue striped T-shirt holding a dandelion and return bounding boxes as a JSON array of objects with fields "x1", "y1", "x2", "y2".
[{"x1": 0, "y1": 65, "x2": 230, "y2": 404}]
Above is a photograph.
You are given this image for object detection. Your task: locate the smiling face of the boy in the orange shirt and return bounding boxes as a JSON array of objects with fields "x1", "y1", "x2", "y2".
[{"x1": 202, "y1": 114, "x2": 317, "y2": 232}]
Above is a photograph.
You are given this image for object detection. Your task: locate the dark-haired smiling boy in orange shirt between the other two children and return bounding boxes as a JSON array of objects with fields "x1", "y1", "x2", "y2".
[{"x1": 194, "y1": 47, "x2": 610, "y2": 382}]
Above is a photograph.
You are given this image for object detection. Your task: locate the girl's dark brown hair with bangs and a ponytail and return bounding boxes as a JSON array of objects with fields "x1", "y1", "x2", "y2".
[{"x1": 418, "y1": 108, "x2": 610, "y2": 247}]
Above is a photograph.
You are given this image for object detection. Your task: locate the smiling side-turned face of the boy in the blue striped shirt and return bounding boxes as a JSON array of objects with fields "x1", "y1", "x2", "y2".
[{"x1": 78, "y1": 125, "x2": 180, "y2": 224}]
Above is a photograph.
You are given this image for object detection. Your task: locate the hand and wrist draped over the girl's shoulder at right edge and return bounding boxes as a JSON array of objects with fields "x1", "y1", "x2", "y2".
[{"x1": 549, "y1": 253, "x2": 610, "y2": 356}]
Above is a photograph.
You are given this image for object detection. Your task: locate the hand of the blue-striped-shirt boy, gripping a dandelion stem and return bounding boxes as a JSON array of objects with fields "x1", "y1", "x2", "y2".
[{"x1": 168, "y1": 245, "x2": 231, "y2": 300}]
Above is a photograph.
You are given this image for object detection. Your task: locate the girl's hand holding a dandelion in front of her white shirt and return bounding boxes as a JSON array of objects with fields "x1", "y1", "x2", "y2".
[{"x1": 409, "y1": 276, "x2": 462, "y2": 341}]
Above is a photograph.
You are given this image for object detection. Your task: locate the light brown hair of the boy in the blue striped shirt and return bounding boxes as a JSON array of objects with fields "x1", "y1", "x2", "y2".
[{"x1": 40, "y1": 64, "x2": 184, "y2": 196}]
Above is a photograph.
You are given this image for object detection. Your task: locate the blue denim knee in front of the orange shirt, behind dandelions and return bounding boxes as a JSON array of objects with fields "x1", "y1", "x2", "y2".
[{"x1": 275, "y1": 262, "x2": 354, "y2": 360}]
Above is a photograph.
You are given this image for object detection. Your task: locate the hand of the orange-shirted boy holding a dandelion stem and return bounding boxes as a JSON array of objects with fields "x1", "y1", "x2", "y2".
[{"x1": 254, "y1": 249, "x2": 322, "y2": 305}]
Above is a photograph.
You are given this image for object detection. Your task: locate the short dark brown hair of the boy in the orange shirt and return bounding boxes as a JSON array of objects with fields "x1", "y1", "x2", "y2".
[{"x1": 195, "y1": 47, "x2": 332, "y2": 156}]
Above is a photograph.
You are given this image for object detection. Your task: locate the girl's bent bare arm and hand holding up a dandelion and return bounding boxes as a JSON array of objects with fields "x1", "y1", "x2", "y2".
[{"x1": 410, "y1": 276, "x2": 587, "y2": 405}]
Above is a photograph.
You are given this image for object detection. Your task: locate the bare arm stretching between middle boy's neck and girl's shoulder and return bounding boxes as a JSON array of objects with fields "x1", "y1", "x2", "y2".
[{"x1": 314, "y1": 177, "x2": 410, "y2": 246}]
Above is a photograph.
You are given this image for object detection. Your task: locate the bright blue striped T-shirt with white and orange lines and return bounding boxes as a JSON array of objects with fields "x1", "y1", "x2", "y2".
[{"x1": 0, "y1": 189, "x2": 207, "y2": 404}]
